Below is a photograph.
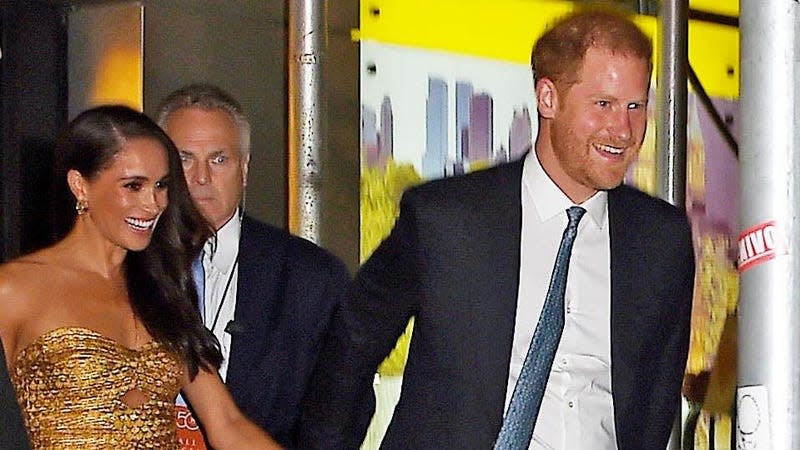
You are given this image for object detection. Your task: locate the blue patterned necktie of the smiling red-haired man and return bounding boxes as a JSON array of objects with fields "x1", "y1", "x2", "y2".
[{"x1": 494, "y1": 206, "x2": 586, "y2": 450}]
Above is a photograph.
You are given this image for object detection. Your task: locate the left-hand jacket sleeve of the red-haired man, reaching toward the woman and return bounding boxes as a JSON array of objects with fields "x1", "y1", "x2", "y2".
[{"x1": 298, "y1": 196, "x2": 420, "y2": 449}]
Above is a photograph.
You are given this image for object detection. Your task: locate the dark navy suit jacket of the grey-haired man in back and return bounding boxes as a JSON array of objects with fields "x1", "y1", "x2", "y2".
[{"x1": 226, "y1": 216, "x2": 350, "y2": 447}]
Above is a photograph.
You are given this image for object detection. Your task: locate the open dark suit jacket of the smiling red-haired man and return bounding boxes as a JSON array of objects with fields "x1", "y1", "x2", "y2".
[{"x1": 301, "y1": 161, "x2": 694, "y2": 449}]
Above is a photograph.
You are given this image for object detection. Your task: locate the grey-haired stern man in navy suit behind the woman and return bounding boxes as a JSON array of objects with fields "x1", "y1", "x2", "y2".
[{"x1": 158, "y1": 84, "x2": 349, "y2": 447}]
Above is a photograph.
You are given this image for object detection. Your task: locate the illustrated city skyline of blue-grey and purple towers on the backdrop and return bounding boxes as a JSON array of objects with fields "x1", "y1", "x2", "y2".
[{"x1": 361, "y1": 76, "x2": 531, "y2": 179}]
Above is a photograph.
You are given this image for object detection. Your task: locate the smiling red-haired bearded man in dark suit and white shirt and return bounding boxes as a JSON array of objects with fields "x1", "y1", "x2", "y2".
[{"x1": 300, "y1": 11, "x2": 694, "y2": 449}]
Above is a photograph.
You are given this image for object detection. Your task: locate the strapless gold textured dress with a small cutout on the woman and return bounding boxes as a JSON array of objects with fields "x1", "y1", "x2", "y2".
[{"x1": 11, "y1": 327, "x2": 183, "y2": 450}]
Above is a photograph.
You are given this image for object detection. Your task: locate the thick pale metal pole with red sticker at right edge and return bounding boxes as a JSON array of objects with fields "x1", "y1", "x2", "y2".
[{"x1": 736, "y1": 0, "x2": 800, "y2": 450}]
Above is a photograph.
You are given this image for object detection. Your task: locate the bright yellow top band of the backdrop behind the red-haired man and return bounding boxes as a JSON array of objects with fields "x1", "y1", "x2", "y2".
[{"x1": 358, "y1": 0, "x2": 739, "y2": 98}]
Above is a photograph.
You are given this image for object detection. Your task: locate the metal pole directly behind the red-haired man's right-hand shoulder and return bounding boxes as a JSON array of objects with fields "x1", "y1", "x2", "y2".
[{"x1": 656, "y1": 0, "x2": 689, "y2": 450}]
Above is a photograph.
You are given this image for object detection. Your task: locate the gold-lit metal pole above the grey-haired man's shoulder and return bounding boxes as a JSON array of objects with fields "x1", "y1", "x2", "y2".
[{"x1": 288, "y1": 0, "x2": 327, "y2": 243}]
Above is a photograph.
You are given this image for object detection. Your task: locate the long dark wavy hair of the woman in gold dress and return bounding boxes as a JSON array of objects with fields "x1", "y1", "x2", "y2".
[{"x1": 52, "y1": 106, "x2": 222, "y2": 378}]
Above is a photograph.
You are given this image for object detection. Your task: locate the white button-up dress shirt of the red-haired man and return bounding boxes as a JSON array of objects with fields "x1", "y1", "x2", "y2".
[{"x1": 506, "y1": 151, "x2": 616, "y2": 450}]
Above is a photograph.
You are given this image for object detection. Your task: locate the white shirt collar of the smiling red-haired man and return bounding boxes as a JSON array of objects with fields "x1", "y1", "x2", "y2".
[{"x1": 522, "y1": 149, "x2": 608, "y2": 228}]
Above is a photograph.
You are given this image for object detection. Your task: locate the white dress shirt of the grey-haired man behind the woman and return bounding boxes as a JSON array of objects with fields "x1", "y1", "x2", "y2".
[{"x1": 203, "y1": 211, "x2": 242, "y2": 381}]
